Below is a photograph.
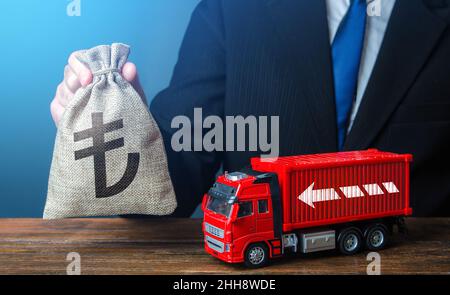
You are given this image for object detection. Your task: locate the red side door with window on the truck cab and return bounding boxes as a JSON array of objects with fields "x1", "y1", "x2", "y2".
[{"x1": 233, "y1": 200, "x2": 256, "y2": 239}]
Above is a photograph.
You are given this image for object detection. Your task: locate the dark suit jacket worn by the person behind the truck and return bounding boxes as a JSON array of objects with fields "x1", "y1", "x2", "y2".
[{"x1": 151, "y1": 0, "x2": 450, "y2": 216}]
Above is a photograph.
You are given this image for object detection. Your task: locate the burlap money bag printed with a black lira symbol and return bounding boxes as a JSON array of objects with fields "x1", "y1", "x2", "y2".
[{"x1": 44, "y1": 44, "x2": 176, "y2": 219}]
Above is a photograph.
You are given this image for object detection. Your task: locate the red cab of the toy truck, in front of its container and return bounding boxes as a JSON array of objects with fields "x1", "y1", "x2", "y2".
[{"x1": 202, "y1": 172, "x2": 281, "y2": 264}]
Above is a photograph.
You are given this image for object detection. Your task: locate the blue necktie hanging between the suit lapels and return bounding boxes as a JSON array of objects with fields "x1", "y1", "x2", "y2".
[{"x1": 331, "y1": 0, "x2": 367, "y2": 150}]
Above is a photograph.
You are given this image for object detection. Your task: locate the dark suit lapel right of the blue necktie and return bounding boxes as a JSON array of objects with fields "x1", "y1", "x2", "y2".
[{"x1": 344, "y1": 0, "x2": 446, "y2": 150}]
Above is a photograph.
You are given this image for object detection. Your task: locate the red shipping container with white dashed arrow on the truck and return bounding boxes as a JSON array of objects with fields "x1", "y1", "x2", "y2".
[{"x1": 252, "y1": 149, "x2": 412, "y2": 231}]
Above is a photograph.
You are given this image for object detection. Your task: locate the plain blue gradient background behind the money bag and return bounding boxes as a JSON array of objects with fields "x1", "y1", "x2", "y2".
[{"x1": 0, "y1": 0, "x2": 199, "y2": 217}]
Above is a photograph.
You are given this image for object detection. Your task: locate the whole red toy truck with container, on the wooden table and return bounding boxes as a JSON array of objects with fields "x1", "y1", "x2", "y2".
[{"x1": 202, "y1": 149, "x2": 412, "y2": 267}]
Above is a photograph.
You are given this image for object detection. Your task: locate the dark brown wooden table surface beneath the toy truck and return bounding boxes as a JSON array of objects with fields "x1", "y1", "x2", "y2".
[{"x1": 0, "y1": 218, "x2": 450, "y2": 274}]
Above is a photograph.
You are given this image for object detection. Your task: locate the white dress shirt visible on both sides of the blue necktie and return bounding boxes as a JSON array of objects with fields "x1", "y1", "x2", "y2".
[{"x1": 326, "y1": 0, "x2": 396, "y2": 132}]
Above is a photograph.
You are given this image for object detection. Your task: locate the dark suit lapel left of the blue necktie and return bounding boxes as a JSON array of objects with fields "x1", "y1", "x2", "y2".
[{"x1": 266, "y1": 0, "x2": 337, "y2": 151}]
